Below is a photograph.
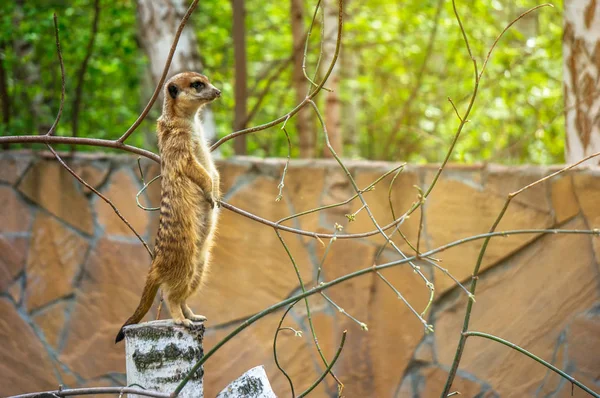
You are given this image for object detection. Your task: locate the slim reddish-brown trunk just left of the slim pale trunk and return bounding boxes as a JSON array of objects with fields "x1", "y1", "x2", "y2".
[{"x1": 290, "y1": 0, "x2": 316, "y2": 158}]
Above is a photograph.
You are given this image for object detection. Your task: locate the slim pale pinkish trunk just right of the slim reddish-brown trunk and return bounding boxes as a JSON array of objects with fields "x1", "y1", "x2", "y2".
[{"x1": 321, "y1": 0, "x2": 343, "y2": 158}]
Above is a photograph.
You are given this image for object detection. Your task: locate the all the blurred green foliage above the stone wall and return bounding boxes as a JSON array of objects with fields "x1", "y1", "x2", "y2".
[{"x1": 0, "y1": 0, "x2": 564, "y2": 164}]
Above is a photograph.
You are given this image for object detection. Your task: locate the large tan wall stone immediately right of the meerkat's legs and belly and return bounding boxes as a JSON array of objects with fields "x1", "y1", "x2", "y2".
[{"x1": 190, "y1": 178, "x2": 313, "y2": 325}]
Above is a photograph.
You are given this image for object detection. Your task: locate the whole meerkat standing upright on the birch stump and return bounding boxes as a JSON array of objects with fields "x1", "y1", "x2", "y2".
[{"x1": 115, "y1": 72, "x2": 221, "y2": 343}]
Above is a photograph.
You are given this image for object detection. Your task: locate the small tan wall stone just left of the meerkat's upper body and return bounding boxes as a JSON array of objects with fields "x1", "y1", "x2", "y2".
[{"x1": 94, "y1": 169, "x2": 150, "y2": 238}]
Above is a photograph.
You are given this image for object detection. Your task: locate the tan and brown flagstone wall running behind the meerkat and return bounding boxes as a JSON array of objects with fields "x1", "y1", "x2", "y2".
[{"x1": 0, "y1": 152, "x2": 600, "y2": 397}]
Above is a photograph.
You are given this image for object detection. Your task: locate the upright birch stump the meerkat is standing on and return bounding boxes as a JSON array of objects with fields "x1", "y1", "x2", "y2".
[{"x1": 125, "y1": 319, "x2": 204, "y2": 398}]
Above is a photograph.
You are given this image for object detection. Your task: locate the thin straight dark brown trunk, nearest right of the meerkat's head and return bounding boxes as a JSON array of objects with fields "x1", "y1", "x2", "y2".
[{"x1": 231, "y1": 0, "x2": 248, "y2": 155}]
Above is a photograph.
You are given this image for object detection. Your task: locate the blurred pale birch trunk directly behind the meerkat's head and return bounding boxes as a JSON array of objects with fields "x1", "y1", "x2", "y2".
[{"x1": 137, "y1": 0, "x2": 216, "y2": 142}]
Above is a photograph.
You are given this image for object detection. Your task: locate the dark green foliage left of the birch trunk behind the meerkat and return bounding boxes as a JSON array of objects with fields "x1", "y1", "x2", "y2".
[{"x1": 0, "y1": 0, "x2": 145, "y2": 149}]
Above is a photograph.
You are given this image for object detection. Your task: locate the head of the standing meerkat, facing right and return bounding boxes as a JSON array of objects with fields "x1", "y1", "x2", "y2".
[{"x1": 163, "y1": 72, "x2": 221, "y2": 118}]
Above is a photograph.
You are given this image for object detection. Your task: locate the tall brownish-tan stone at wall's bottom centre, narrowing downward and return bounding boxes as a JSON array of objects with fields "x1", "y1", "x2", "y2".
[{"x1": 324, "y1": 240, "x2": 429, "y2": 397}]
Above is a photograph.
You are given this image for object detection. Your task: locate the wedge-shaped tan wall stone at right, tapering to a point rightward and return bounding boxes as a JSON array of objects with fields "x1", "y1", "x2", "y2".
[{"x1": 425, "y1": 174, "x2": 553, "y2": 294}]
